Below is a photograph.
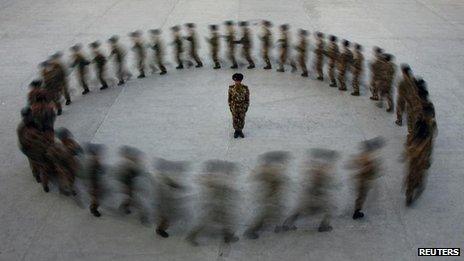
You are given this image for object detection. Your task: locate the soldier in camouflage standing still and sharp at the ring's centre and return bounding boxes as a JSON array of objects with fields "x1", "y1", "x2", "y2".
[{"x1": 228, "y1": 73, "x2": 250, "y2": 139}]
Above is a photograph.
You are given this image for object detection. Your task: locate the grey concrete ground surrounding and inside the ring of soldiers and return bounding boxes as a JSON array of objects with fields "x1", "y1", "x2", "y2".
[{"x1": 0, "y1": 0, "x2": 464, "y2": 260}]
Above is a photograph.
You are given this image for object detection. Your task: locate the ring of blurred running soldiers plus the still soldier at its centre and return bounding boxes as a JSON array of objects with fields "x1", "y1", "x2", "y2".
[{"x1": 17, "y1": 21, "x2": 437, "y2": 245}]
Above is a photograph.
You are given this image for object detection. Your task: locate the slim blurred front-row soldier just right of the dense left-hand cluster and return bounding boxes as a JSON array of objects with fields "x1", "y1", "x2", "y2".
[{"x1": 85, "y1": 144, "x2": 105, "y2": 217}]
